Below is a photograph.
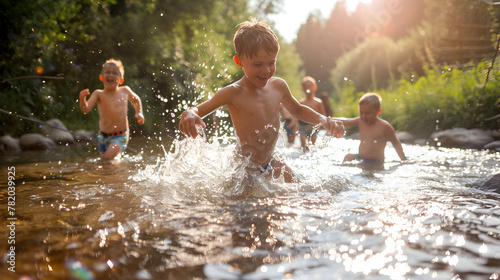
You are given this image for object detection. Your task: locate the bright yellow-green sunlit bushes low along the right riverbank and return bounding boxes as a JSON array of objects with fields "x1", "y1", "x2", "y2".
[{"x1": 332, "y1": 62, "x2": 500, "y2": 137}]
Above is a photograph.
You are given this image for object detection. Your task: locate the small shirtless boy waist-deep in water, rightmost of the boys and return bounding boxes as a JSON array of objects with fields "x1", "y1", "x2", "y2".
[{"x1": 335, "y1": 93, "x2": 406, "y2": 163}]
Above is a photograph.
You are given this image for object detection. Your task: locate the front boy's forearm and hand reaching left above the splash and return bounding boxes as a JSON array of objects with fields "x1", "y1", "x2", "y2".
[{"x1": 179, "y1": 86, "x2": 232, "y2": 138}]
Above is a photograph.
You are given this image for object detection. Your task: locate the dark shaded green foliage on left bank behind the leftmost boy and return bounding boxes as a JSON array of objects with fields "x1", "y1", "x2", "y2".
[{"x1": 0, "y1": 0, "x2": 249, "y2": 135}]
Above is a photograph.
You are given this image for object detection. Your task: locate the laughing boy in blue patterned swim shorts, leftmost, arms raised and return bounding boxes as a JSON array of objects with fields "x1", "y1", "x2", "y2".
[{"x1": 80, "y1": 59, "x2": 144, "y2": 160}]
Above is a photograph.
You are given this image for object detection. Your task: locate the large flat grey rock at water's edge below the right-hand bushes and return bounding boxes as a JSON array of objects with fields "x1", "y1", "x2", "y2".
[{"x1": 431, "y1": 128, "x2": 494, "y2": 149}]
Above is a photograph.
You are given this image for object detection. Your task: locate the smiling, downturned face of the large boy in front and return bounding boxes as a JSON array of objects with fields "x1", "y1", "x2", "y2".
[{"x1": 234, "y1": 49, "x2": 278, "y2": 87}]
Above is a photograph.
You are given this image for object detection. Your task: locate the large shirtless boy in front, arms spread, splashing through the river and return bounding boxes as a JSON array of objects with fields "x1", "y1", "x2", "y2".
[{"x1": 179, "y1": 19, "x2": 344, "y2": 182}]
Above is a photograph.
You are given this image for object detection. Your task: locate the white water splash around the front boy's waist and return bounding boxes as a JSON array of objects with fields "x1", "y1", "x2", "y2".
[{"x1": 134, "y1": 126, "x2": 304, "y2": 200}]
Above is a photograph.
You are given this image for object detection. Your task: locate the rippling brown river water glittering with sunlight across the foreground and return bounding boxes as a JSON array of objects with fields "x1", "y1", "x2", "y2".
[{"x1": 0, "y1": 134, "x2": 500, "y2": 280}]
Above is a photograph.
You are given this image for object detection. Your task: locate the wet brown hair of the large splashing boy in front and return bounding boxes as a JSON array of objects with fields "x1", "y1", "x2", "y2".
[{"x1": 233, "y1": 18, "x2": 280, "y2": 58}]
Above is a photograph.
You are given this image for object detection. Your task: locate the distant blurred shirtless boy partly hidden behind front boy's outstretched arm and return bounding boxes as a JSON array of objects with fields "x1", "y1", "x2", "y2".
[{"x1": 299, "y1": 76, "x2": 326, "y2": 151}]
